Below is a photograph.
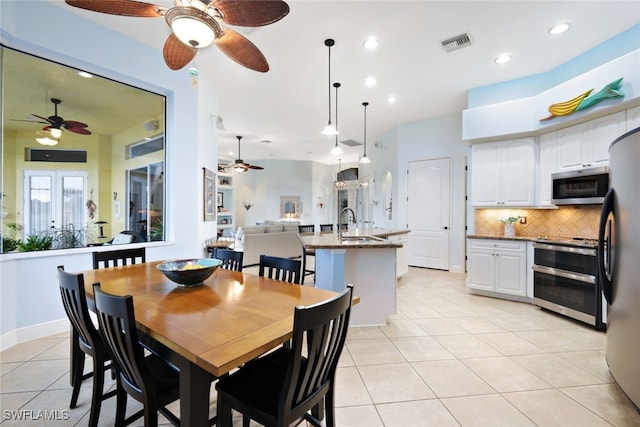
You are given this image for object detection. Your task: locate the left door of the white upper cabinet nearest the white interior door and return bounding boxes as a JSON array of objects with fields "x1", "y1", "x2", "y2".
[{"x1": 471, "y1": 143, "x2": 500, "y2": 206}]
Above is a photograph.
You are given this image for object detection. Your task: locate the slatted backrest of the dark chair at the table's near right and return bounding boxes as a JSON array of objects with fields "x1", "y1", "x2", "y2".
[{"x1": 278, "y1": 285, "x2": 353, "y2": 419}]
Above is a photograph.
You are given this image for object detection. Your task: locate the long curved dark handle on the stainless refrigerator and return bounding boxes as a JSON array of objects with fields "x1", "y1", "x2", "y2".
[{"x1": 598, "y1": 188, "x2": 615, "y2": 305}]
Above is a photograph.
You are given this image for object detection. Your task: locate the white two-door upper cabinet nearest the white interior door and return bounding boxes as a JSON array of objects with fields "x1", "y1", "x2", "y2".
[{"x1": 471, "y1": 138, "x2": 535, "y2": 207}]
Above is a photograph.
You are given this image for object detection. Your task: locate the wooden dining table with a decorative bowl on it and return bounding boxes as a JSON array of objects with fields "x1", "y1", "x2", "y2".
[{"x1": 82, "y1": 261, "x2": 337, "y2": 427}]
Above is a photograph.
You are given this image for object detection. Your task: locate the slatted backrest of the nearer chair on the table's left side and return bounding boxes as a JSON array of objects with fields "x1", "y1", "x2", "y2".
[{"x1": 93, "y1": 283, "x2": 149, "y2": 397}]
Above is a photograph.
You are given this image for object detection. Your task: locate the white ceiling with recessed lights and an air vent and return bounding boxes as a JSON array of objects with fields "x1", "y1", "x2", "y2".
[{"x1": 40, "y1": 0, "x2": 640, "y2": 164}]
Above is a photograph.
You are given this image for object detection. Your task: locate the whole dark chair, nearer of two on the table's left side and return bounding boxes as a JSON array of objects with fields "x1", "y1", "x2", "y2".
[{"x1": 93, "y1": 283, "x2": 180, "y2": 427}]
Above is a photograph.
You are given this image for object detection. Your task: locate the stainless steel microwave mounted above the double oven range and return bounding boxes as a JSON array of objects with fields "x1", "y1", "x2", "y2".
[{"x1": 551, "y1": 166, "x2": 609, "y2": 205}]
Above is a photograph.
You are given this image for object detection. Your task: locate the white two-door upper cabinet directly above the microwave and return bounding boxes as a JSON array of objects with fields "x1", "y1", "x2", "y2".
[{"x1": 557, "y1": 111, "x2": 627, "y2": 170}]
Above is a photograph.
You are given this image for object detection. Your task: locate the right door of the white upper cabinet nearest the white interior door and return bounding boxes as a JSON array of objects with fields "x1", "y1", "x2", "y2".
[{"x1": 500, "y1": 138, "x2": 535, "y2": 206}]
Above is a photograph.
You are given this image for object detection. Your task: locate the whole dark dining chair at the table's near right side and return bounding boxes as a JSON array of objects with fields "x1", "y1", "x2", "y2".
[{"x1": 216, "y1": 285, "x2": 353, "y2": 427}]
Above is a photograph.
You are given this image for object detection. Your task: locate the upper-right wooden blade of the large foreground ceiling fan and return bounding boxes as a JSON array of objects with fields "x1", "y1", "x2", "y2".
[{"x1": 213, "y1": 0, "x2": 289, "y2": 27}]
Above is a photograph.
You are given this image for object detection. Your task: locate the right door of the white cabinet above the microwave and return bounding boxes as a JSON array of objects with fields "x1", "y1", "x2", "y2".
[{"x1": 585, "y1": 111, "x2": 627, "y2": 166}]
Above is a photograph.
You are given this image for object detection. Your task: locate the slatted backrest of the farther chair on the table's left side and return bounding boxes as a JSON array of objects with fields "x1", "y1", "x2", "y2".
[{"x1": 58, "y1": 265, "x2": 103, "y2": 355}]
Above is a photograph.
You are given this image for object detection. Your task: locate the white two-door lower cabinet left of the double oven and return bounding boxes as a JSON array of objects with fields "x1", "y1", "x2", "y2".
[{"x1": 467, "y1": 239, "x2": 528, "y2": 301}]
